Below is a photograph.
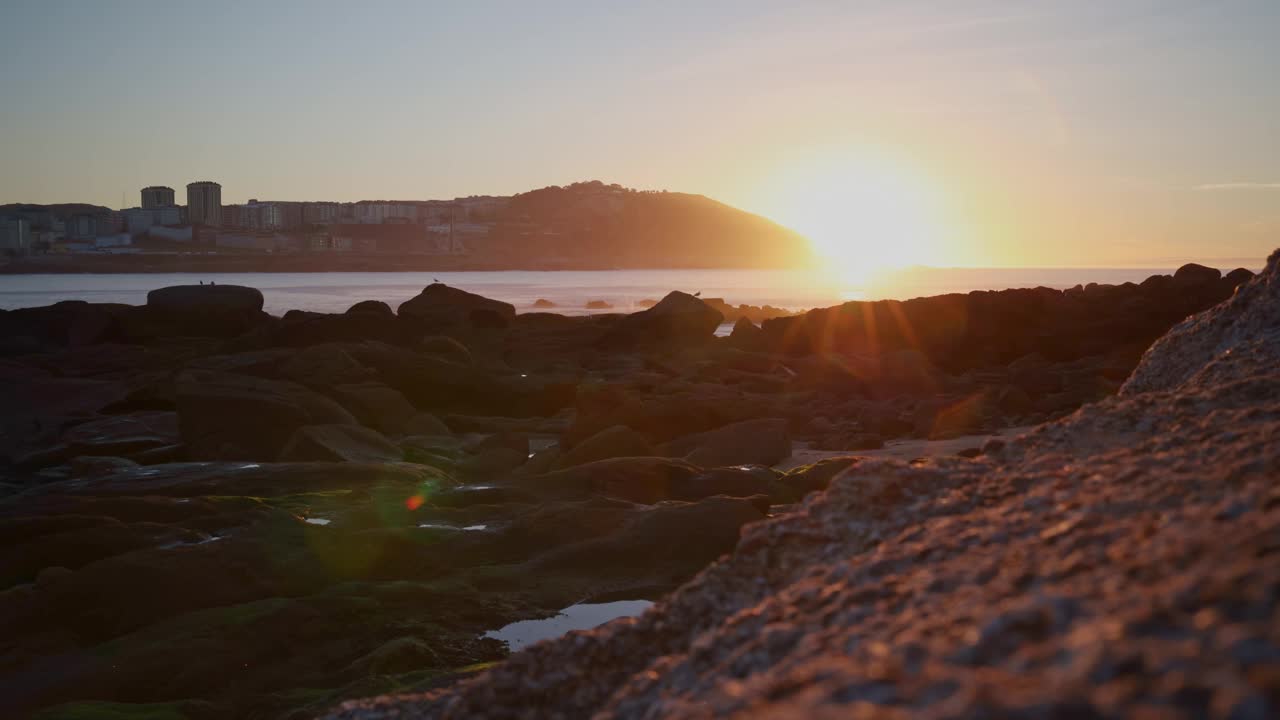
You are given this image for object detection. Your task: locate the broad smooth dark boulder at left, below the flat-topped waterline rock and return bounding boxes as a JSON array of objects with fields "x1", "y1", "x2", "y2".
[{"x1": 175, "y1": 370, "x2": 357, "y2": 460}]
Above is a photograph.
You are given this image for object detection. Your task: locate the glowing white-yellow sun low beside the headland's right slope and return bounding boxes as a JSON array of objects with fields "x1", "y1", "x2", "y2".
[{"x1": 769, "y1": 149, "x2": 945, "y2": 284}]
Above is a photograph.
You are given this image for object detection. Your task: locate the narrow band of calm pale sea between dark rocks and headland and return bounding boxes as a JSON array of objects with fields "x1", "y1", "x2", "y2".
[{"x1": 0, "y1": 263, "x2": 1261, "y2": 315}]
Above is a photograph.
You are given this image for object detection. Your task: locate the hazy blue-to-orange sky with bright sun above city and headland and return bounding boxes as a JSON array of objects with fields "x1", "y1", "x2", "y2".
[{"x1": 0, "y1": 0, "x2": 1280, "y2": 266}]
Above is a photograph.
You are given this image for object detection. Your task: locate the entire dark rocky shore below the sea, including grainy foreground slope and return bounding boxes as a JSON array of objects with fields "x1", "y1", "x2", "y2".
[{"x1": 0, "y1": 256, "x2": 1259, "y2": 720}]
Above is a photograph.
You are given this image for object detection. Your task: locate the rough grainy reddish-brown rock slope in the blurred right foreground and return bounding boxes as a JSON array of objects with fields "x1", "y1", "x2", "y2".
[{"x1": 332, "y1": 254, "x2": 1280, "y2": 720}]
